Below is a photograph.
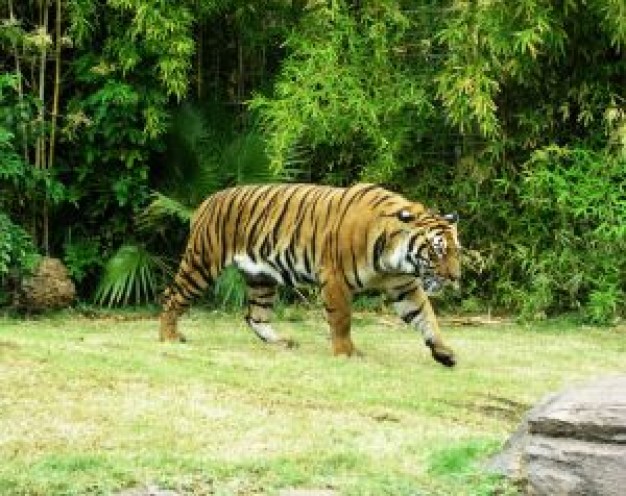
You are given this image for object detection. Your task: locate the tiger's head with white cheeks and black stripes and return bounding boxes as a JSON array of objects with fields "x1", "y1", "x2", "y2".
[{"x1": 374, "y1": 203, "x2": 461, "y2": 294}]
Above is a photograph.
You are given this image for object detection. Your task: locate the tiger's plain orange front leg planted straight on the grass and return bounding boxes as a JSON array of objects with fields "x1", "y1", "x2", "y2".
[{"x1": 322, "y1": 279, "x2": 361, "y2": 356}]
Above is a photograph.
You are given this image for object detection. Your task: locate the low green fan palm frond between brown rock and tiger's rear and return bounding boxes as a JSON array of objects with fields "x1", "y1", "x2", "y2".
[{"x1": 95, "y1": 245, "x2": 164, "y2": 307}]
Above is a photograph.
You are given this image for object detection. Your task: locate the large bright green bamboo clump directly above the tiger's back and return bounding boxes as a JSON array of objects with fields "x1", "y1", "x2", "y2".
[{"x1": 251, "y1": 1, "x2": 429, "y2": 182}]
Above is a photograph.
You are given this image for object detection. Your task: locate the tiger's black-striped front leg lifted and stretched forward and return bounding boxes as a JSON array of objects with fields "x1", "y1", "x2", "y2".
[{"x1": 387, "y1": 279, "x2": 456, "y2": 367}]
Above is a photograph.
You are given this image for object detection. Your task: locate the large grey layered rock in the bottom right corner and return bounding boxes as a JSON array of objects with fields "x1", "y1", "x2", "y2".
[{"x1": 489, "y1": 375, "x2": 626, "y2": 496}]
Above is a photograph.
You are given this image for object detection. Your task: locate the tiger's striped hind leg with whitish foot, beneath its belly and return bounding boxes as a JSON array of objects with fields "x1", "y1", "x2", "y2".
[{"x1": 245, "y1": 277, "x2": 296, "y2": 348}]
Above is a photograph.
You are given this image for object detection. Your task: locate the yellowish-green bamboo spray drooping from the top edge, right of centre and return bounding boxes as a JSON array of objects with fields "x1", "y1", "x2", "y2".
[{"x1": 437, "y1": 0, "x2": 566, "y2": 139}]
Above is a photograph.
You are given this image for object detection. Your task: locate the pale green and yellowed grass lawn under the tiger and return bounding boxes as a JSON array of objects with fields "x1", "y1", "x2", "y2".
[{"x1": 0, "y1": 311, "x2": 626, "y2": 496}]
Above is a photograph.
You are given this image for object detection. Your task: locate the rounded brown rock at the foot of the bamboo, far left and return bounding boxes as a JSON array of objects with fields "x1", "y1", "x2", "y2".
[{"x1": 14, "y1": 257, "x2": 76, "y2": 312}]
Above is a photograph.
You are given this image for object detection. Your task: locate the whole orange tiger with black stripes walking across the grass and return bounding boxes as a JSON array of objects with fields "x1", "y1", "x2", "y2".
[{"x1": 160, "y1": 183, "x2": 461, "y2": 367}]
